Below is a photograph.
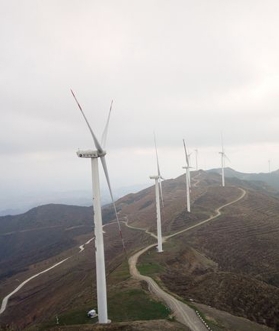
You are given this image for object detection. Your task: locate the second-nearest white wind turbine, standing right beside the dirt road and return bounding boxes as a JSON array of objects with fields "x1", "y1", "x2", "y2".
[{"x1": 149, "y1": 134, "x2": 164, "y2": 253}]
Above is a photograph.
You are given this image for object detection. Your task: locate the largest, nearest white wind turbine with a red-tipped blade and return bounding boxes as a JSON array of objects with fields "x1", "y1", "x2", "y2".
[{"x1": 71, "y1": 90, "x2": 124, "y2": 324}]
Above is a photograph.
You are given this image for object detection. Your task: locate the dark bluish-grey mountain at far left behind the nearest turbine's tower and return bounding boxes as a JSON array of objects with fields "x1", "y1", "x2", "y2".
[{"x1": 0, "y1": 204, "x2": 118, "y2": 280}]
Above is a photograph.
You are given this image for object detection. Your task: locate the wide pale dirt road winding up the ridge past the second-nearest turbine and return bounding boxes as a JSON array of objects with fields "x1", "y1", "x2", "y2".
[{"x1": 127, "y1": 188, "x2": 246, "y2": 331}]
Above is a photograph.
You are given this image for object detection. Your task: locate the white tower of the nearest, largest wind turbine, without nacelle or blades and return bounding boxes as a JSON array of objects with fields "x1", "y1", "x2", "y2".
[{"x1": 91, "y1": 157, "x2": 110, "y2": 324}]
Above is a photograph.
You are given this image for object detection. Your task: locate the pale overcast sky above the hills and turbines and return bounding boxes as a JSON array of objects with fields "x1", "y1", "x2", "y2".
[{"x1": 0, "y1": 0, "x2": 279, "y2": 210}]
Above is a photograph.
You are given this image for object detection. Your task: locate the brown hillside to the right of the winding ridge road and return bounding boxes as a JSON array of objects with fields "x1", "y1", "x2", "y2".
[{"x1": 136, "y1": 175, "x2": 279, "y2": 327}]
